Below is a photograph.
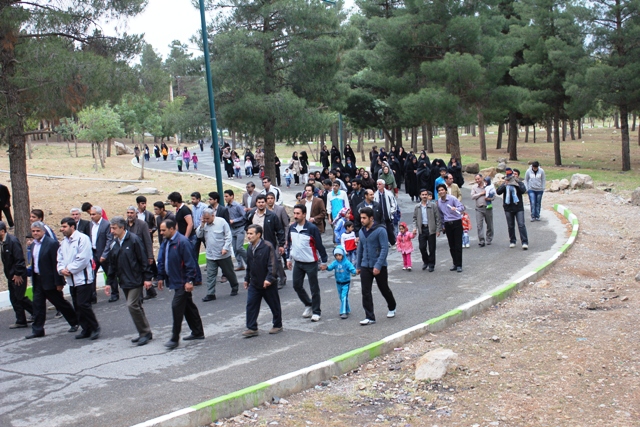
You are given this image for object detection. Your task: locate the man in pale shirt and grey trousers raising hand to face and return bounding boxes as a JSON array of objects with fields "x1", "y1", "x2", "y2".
[{"x1": 196, "y1": 208, "x2": 238, "y2": 302}]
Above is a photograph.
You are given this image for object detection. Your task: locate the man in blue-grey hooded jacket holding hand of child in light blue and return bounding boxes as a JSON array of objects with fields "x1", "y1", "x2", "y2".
[{"x1": 356, "y1": 208, "x2": 396, "y2": 326}]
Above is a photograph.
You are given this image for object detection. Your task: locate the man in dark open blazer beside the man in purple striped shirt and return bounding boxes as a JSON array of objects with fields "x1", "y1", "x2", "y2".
[{"x1": 413, "y1": 188, "x2": 442, "y2": 272}]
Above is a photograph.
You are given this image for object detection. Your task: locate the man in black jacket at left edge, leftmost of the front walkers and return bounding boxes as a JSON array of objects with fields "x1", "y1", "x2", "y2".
[{"x1": 0, "y1": 221, "x2": 33, "y2": 329}]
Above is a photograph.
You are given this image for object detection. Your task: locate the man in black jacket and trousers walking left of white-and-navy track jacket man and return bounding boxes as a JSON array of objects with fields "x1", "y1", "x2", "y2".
[{"x1": 242, "y1": 224, "x2": 282, "y2": 338}]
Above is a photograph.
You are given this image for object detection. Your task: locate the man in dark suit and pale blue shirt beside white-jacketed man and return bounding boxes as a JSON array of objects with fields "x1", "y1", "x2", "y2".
[{"x1": 26, "y1": 221, "x2": 78, "y2": 339}]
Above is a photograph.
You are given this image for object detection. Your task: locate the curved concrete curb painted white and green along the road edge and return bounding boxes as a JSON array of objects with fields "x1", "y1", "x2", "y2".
[{"x1": 133, "y1": 204, "x2": 579, "y2": 427}]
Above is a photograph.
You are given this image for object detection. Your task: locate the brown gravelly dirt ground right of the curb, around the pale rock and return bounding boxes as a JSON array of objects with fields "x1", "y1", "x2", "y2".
[{"x1": 212, "y1": 190, "x2": 640, "y2": 427}]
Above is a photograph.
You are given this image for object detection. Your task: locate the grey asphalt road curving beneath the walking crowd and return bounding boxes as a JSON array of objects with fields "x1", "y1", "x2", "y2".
[{"x1": 0, "y1": 148, "x2": 565, "y2": 427}]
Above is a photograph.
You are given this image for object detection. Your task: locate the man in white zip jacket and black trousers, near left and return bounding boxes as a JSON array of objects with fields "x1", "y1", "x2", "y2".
[{"x1": 57, "y1": 217, "x2": 100, "y2": 340}]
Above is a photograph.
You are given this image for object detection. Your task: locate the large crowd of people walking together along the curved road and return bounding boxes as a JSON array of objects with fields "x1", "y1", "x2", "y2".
[{"x1": 0, "y1": 145, "x2": 545, "y2": 349}]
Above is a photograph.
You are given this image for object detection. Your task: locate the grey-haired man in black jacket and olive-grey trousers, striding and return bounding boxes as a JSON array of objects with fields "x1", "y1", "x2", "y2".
[{"x1": 107, "y1": 216, "x2": 153, "y2": 345}]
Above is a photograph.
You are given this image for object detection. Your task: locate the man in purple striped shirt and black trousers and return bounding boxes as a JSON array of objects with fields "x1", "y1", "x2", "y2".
[{"x1": 438, "y1": 184, "x2": 465, "y2": 273}]
